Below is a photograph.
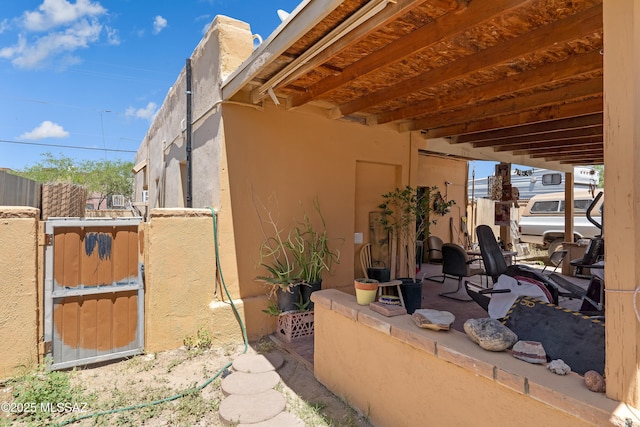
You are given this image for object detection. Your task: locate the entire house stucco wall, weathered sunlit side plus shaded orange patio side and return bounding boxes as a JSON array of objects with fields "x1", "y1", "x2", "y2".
[{"x1": 136, "y1": 12, "x2": 466, "y2": 337}]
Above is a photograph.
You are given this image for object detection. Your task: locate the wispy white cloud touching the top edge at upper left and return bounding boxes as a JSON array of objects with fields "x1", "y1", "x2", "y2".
[{"x1": 23, "y1": 0, "x2": 107, "y2": 31}]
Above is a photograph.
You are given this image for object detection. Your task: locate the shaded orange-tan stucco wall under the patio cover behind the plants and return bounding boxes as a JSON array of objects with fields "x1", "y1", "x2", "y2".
[{"x1": 222, "y1": 105, "x2": 466, "y2": 312}]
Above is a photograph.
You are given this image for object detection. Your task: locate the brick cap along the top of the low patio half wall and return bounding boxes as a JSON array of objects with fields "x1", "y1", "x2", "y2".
[{"x1": 311, "y1": 289, "x2": 621, "y2": 425}]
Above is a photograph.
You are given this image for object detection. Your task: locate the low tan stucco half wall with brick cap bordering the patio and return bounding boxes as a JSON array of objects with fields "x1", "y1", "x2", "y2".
[{"x1": 312, "y1": 290, "x2": 618, "y2": 427}]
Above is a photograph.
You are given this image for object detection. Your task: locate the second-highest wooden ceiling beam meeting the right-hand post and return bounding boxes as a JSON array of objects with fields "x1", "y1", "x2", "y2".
[{"x1": 376, "y1": 51, "x2": 602, "y2": 124}]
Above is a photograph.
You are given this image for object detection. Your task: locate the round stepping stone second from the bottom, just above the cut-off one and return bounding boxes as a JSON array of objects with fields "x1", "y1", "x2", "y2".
[{"x1": 218, "y1": 390, "x2": 286, "y2": 425}]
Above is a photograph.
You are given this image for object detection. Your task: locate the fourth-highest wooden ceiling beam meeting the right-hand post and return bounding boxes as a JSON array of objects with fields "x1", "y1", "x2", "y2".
[{"x1": 418, "y1": 97, "x2": 604, "y2": 139}]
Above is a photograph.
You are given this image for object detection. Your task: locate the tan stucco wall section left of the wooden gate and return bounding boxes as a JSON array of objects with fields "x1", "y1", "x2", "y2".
[{"x1": 0, "y1": 206, "x2": 40, "y2": 378}]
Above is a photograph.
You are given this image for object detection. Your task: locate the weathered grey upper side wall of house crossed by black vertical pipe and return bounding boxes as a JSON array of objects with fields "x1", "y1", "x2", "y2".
[{"x1": 135, "y1": 16, "x2": 253, "y2": 214}]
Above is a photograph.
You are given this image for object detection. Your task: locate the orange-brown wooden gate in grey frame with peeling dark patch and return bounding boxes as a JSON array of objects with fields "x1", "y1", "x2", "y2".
[{"x1": 44, "y1": 218, "x2": 144, "y2": 369}]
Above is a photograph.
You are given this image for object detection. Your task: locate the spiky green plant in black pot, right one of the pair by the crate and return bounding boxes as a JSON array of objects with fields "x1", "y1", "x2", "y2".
[{"x1": 288, "y1": 200, "x2": 340, "y2": 310}]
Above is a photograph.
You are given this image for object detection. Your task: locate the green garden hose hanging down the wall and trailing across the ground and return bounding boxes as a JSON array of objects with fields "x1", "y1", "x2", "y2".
[{"x1": 58, "y1": 207, "x2": 249, "y2": 427}]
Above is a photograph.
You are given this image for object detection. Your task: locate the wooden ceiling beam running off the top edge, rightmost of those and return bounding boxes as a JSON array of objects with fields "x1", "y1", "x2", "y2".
[{"x1": 291, "y1": 0, "x2": 530, "y2": 107}]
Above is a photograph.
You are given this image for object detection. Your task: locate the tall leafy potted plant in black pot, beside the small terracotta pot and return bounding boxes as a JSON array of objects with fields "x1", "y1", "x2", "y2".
[{"x1": 378, "y1": 185, "x2": 455, "y2": 313}]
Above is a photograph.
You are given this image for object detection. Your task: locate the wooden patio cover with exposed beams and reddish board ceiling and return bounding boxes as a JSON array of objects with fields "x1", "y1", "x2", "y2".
[{"x1": 223, "y1": 0, "x2": 604, "y2": 170}]
